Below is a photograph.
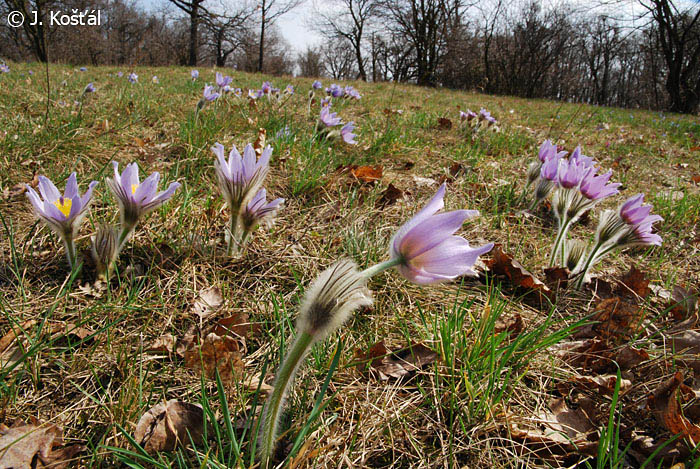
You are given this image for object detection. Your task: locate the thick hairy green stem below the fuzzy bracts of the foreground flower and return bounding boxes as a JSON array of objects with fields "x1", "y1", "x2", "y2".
[{"x1": 259, "y1": 332, "x2": 314, "y2": 468}]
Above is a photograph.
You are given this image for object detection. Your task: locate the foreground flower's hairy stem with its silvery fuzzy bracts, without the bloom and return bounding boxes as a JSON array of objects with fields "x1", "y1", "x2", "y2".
[{"x1": 258, "y1": 260, "x2": 372, "y2": 468}]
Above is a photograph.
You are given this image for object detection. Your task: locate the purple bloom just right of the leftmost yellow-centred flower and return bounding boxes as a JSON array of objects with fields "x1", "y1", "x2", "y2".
[{"x1": 105, "y1": 161, "x2": 180, "y2": 228}]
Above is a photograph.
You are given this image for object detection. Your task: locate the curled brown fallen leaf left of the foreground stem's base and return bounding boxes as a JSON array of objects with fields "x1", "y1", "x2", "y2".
[{"x1": 134, "y1": 399, "x2": 204, "y2": 454}]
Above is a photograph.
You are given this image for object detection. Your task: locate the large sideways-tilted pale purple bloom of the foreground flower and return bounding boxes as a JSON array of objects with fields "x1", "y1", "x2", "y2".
[{"x1": 389, "y1": 184, "x2": 493, "y2": 284}]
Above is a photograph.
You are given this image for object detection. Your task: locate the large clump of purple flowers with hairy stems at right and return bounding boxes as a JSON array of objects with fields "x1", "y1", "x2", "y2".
[{"x1": 526, "y1": 140, "x2": 662, "y2": 288}]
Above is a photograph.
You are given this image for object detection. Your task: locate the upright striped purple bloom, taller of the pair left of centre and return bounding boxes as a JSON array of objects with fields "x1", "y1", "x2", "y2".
[{"x1": 211, "y1": 142, "x2": 272, "y2": 210}]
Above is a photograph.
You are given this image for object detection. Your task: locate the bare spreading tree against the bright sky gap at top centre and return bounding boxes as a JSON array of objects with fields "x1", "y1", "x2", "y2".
[{"x1": 310, "y1": 0, "x2": 378, "y2": 81}]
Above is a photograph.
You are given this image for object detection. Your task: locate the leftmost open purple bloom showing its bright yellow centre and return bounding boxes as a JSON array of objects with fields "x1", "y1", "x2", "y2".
[{"x1": 26, "y1": 173, "x2": 97, "y2": 242}]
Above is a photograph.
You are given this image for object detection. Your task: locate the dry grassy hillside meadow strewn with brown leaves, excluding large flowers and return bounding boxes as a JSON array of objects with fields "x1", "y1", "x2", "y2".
[{"x1": 0, "y1": 63, "x2": 700, "y2": 468}]
